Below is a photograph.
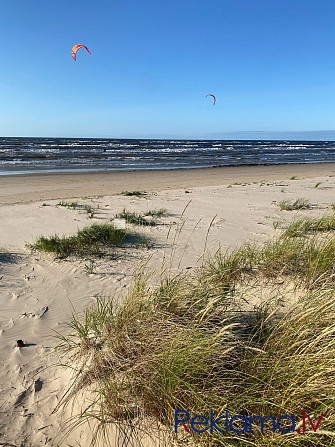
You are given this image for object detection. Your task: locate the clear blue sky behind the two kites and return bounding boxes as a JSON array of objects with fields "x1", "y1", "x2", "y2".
[{"x1": 0, "y1": 0, "x2": 335, "y2": 138}]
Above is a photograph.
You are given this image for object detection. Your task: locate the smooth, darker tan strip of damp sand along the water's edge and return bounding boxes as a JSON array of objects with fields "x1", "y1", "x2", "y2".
[{"x1": 0, "y1": 162, "x2": 335, "y2": 205}]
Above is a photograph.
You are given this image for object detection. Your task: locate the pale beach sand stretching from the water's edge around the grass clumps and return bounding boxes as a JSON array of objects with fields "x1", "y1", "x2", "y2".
[{"x1": 0, "y1": 164, "x2": 335, "y2": 447}]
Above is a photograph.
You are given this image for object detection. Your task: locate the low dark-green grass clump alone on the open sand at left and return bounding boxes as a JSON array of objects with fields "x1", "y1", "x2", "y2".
[{"x1": 27, "y1": 224, "x2": 148, "y2": 258}]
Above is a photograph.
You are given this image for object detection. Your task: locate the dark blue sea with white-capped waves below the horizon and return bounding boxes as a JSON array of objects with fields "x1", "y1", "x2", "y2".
[{"x1": 0, "y1": 138, "x2": 335, "y2": 175}]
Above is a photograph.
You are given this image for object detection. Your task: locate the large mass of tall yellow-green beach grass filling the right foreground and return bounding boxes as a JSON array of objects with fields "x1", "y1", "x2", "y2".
[{"x1": 60, "y1": 217, "x2": 335, "y2": 447}]
